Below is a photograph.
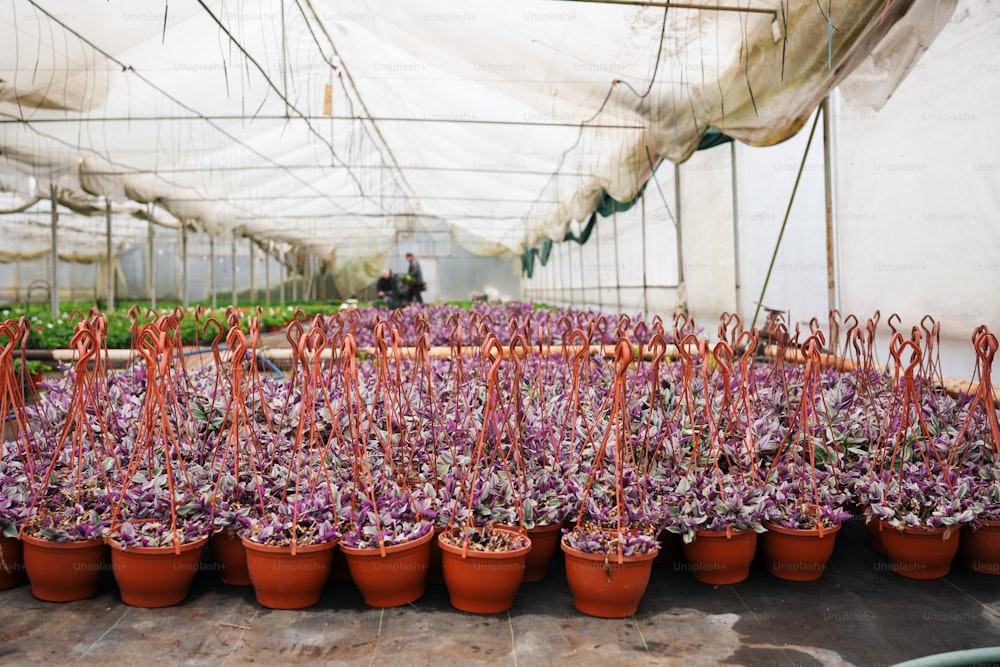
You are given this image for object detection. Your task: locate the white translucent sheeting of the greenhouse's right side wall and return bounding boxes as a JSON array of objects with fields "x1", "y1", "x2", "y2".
[{"x1": 525, "y1": 2, "x2": 1000, "y2": 379}]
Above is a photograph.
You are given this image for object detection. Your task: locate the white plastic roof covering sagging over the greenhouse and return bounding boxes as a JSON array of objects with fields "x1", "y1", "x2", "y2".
[{"x1": 0, "y1": 0, "x2": 913, "y2": 290}]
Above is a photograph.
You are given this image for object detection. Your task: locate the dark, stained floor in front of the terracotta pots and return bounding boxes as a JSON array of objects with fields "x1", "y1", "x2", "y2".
[{"x1": 0, "y1": 522, "x2": 1000, "y2": 666}]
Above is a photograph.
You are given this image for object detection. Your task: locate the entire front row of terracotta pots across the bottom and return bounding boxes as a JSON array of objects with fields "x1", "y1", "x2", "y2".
[{"x1": 0, "y1": 522, "x2": 1000, "y2": 617}]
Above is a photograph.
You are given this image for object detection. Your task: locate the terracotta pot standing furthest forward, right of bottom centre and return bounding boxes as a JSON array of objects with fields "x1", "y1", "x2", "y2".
[{"x1": 561, "y1": 542, "x2": 658, "y2": 618}]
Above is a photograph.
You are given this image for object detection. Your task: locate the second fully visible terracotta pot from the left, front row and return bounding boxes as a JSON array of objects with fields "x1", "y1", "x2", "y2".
[{"x1": 107, "y1": 536, "x2": 208, "y2": 609}]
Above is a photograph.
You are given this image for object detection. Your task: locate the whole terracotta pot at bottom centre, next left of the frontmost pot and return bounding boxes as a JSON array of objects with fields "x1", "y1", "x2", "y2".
[{"x1": 438, "y1": 526, "x2": 531, "y2": 614}]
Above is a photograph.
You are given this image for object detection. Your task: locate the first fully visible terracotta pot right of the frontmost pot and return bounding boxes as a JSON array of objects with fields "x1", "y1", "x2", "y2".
[{"x1": 681, "y1": 529, "x2": 757, "y2": 586}]
